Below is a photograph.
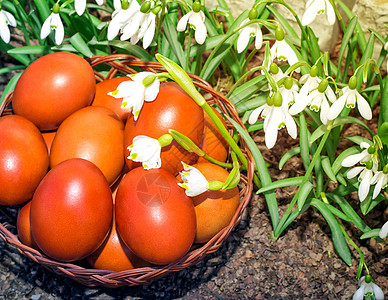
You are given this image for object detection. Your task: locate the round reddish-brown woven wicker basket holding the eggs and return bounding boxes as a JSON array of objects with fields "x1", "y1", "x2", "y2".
[{"x1": 0, "y1": 54, "x2": 254, "y2": 288}]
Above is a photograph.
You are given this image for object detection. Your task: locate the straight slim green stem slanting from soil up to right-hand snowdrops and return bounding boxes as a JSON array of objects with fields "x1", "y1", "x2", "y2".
[{"x1": 274, "y1": 121, "x2": 333, "y2": 238}]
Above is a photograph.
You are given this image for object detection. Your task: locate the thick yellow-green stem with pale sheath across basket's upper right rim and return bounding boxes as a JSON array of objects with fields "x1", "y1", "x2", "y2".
[{"x1": 155, "y1": 54, "x2": 253, "y2": 178}]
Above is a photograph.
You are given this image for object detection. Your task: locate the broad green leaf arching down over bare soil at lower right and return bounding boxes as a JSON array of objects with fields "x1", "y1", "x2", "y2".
[{"x1": 311, "y1": 199, "x2": 352, "y2": 266}]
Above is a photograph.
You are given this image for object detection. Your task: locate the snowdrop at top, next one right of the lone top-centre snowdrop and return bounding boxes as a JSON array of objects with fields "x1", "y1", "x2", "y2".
[{"x1": 237, "y1": 8, "x2": 263, "y2": 53}]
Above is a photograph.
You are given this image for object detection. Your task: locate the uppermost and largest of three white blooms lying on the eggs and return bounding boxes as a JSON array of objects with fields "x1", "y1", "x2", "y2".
[{"x1": 108, "y1": 72, "x2": 160, "y2": 121}]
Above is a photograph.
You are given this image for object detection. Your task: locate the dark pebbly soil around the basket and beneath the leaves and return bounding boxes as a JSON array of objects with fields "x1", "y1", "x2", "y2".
[{"x1": 0, "y1": 52, "x2": 388, "y2": 300}]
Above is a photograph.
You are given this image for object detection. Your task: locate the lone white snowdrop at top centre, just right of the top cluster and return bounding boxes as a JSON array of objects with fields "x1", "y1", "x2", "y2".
[{"x1": 176, "y1": 1, "x2": 207, "y2": 44}]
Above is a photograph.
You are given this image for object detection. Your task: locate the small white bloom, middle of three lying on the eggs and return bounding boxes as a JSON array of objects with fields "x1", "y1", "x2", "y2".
[{"x1": 127, "y1": 135, "x2": 162, "y2": 170}]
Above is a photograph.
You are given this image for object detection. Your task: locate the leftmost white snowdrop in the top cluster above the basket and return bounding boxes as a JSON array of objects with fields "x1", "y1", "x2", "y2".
[{"x1": 107, "y1": 0, "x2": 140, "y2": 41}]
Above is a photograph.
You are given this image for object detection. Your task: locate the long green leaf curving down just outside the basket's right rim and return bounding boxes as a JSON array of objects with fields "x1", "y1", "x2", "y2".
[{"x1": 228, "y1": 117, "x2": 279, "y2": 228}]
